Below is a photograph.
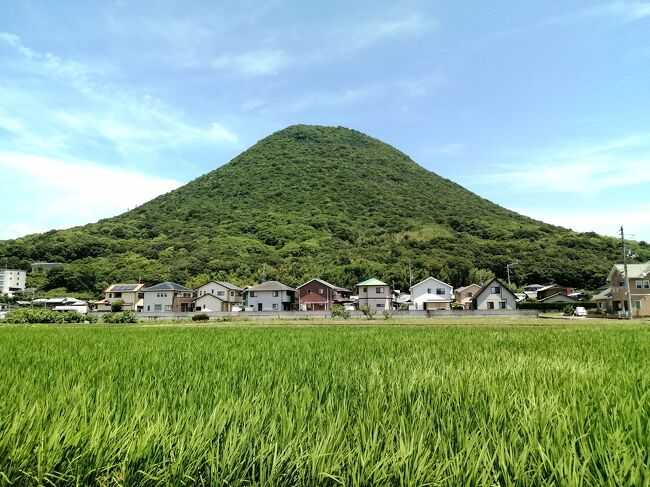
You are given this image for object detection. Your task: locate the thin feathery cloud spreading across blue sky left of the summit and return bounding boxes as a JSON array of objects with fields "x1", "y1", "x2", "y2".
[{"x1": 0, "y1": 33, "x2": 237, "y2": 166}]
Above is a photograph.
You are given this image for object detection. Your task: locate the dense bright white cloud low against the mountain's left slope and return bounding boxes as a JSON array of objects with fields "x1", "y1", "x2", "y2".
[{"x1": 0, "y1": 152, "x2": 181, "y2": 237}]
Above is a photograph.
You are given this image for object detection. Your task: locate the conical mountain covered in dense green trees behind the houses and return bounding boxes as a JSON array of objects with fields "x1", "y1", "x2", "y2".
[{"x1": 0, "y1": 125, "x2": 650, "y2": 292}]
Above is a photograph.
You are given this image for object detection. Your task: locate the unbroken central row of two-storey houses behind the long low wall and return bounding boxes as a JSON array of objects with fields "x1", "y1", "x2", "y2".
[{"x1": 93, "y1": 277, "x2": 518, "y2": 313}]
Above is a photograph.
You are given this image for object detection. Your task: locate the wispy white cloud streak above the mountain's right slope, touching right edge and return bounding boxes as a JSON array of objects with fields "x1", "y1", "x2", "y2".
[{"x1": 478, "y1": 135, "x2": 650, "y2": 194}]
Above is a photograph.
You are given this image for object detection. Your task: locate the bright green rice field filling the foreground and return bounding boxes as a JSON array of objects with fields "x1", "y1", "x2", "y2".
[{"x1": 0, "y1": 320, "x2": 650, "y2": 486}]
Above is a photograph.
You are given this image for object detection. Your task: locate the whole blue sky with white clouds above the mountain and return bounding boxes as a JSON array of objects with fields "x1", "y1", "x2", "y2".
[{"x1": 0, "y1": 0, "x2": 650, "y2": 241}]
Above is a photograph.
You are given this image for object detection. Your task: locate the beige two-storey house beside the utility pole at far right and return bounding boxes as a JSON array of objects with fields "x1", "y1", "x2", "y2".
[{"x1": 607, "y1": 261, "x2": 650, "y2": 318}]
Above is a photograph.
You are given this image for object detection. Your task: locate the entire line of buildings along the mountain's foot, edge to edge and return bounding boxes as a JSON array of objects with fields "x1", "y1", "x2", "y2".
[{"x1": 6, "y1": 261, "x2": 650, "y2": 317}]
